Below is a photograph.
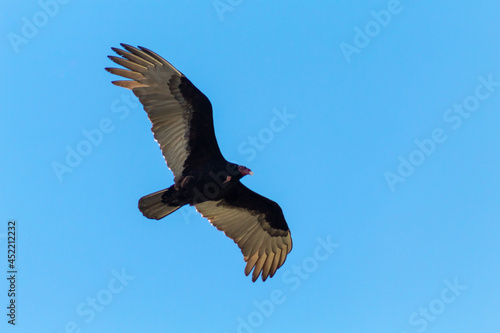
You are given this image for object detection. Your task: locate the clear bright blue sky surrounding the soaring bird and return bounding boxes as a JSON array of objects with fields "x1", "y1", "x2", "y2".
[{"x1": 0, "y1": 0, "x2": 500, "y2": 333}]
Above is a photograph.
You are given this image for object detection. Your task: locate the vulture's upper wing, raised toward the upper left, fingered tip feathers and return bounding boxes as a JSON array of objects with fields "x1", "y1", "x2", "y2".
[{"x1": 106, "y1": 44, "x2": 223, "y2": 181}]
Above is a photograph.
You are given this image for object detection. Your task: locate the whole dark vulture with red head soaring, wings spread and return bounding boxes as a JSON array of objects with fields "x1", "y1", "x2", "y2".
[{"x1": 106, "y1": 44, "x2": 292, "y2": 282}]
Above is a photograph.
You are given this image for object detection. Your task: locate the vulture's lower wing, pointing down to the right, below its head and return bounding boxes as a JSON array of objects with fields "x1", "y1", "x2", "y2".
[{"x1": 195, "y1": 182, "x2": 292, "y2": 282}]
